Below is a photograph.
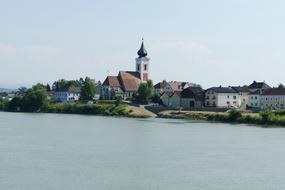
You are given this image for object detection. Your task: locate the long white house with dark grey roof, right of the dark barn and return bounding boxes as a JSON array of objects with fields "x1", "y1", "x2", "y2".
[{"x1": 205, "y1": 86, "x2": 241, "y2": 108}]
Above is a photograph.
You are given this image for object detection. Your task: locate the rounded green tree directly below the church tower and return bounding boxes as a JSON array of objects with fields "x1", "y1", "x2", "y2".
[{"x1": 137, "y1": 80, "x2": 153, "y2": 104}]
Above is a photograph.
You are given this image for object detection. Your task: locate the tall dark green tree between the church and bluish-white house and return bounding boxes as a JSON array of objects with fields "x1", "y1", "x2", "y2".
[{"x1": 80, "y1": 77, "x2": 96, "y2": 101}]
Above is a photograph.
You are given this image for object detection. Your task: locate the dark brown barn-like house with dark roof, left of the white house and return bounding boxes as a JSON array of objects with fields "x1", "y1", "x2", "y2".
[{"x1": 180, "y1": 87, "x2": 204, "y2": 109}]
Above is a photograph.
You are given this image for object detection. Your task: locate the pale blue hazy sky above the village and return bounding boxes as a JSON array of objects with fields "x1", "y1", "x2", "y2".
[{"x1": 0, "y1": 0, "x2": 285, "y2": 88}]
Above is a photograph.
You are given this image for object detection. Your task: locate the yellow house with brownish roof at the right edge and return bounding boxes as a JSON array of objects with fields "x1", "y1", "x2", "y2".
[{"x1": 260, "y1": 88, "x2": 285, "y2": 110}]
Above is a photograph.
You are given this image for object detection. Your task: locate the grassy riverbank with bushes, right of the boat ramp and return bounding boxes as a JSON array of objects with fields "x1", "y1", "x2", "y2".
[{"x1": 158, "y1": 110, "x2": 285, "y2": 127}]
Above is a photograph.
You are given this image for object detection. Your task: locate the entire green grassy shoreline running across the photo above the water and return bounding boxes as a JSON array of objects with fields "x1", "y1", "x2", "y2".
[{"x1": 2, "y1": 102, "x2": 285, "y2": 127}]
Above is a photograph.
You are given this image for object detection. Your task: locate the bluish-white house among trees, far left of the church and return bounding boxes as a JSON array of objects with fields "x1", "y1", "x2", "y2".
[{"x1": 53, "y1": 86, "x2": 81, "y2": 102}]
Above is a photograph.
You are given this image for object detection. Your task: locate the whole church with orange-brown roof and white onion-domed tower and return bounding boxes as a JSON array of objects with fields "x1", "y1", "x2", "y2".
[{"x1": 100, "y1": 41, "x2": 149, "y2": 100}]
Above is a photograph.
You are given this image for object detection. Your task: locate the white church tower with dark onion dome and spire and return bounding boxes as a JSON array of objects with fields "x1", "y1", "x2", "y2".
[{"x1": 136, "y1": 40, "x2": 149, "y2": 82}]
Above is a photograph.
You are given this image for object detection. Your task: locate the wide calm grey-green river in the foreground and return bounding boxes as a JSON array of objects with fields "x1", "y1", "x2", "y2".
[{"x1": 0, "y1": 112, "x2": 285, "y2": 190}]
